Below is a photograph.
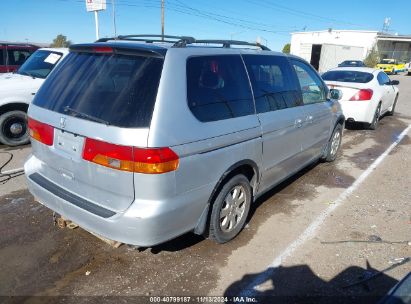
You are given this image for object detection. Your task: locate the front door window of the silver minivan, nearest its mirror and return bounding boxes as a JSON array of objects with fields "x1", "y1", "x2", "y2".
[{"x1": 291, "y1": 60, "x2": 327, "y2": 105}]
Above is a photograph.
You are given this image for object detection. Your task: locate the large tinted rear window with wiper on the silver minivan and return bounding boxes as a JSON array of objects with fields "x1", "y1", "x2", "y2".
[{"x1": 33, "y1": 53, "x2": 163, "y2": 128}]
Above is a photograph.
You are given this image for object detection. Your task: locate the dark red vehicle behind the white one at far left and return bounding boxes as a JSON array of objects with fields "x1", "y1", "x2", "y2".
[{"x1": 0, "y1": 42, "x2": 39, "y2": 73}]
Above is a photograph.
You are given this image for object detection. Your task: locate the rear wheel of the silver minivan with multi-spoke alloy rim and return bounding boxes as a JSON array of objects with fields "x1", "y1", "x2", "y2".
[{"x1": 209, "y1": 174, "x2": 252, "y2": 244}]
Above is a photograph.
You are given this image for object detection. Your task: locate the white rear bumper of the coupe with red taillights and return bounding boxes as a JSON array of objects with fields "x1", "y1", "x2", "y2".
[{"x1": 340, "y1": 100, "x2": 375, "y2": 123}]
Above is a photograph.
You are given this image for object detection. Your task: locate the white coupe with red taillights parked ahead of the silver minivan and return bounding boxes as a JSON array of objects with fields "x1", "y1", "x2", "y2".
[{"x1": 322, "y1": 67, "x2": 399, "y2": 130}]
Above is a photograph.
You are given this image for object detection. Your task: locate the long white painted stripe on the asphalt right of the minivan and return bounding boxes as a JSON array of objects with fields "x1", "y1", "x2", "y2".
[{"x1": 241, "y1": 125, "x2": 411, "y2": 296}]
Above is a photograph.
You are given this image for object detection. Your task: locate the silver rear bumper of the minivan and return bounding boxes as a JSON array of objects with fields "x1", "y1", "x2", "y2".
[{"x1": 24, "y1": 156, "x2": 213, "y2": 247}]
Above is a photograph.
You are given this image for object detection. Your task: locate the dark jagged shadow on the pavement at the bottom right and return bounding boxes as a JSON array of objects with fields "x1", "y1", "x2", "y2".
[{"x1": 224, "y1": 261, "x2": 404, "y2": 304}]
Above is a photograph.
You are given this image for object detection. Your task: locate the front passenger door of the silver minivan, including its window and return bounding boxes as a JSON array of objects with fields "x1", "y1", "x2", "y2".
[{"x1": 291, "y1": 59, "x2": 333, "y2": 162}]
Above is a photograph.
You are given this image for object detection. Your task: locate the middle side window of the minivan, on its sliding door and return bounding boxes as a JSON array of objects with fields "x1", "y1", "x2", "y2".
[{"x1": 243, "y1": 55, "x2": 302, "y2": 113}]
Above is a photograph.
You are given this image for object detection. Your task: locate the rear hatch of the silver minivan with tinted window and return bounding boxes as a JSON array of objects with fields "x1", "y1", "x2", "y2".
[{"x1": 29, "y1": 44, "x2": 165, "y2": 212}]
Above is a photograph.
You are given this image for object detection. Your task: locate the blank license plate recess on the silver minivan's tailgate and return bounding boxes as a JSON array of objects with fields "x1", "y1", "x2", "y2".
[{"x1": 55, "y1": 129, "x2": 84, "y2": 159}]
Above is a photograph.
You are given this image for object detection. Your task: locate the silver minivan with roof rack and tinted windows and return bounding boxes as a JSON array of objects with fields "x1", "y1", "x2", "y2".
[{"x1": 24, "y1": 35, "x2": 344, "y2": 246}]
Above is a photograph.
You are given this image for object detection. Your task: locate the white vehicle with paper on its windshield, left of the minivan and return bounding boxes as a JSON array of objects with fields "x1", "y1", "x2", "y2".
[{"x1": 0, "y1": 48, "x2": 68, "y2": 146}]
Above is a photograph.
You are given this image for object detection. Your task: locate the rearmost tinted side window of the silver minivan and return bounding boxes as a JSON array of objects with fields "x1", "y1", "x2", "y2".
[{"x1": 187, "y1": 55, "x2": 255, "y2": 122}]
